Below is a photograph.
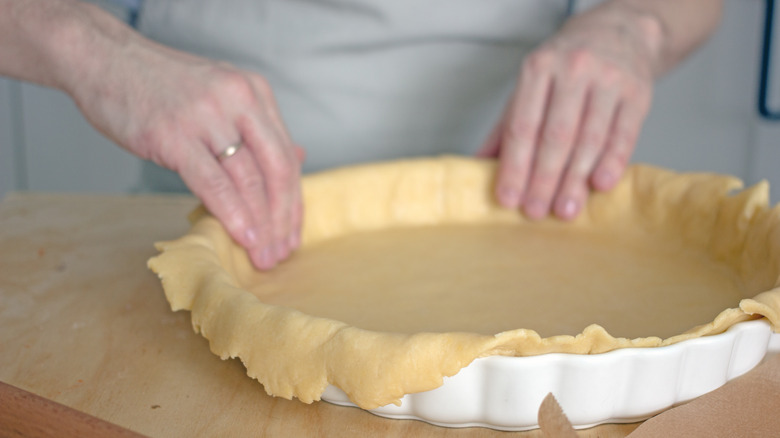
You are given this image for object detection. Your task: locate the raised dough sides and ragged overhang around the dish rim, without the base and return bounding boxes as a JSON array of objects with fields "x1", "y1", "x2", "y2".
[{"x1": 148, "y1": 157, "x2": 780, "y2": 409}]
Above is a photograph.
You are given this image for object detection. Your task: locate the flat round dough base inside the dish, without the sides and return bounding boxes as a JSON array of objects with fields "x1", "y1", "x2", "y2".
[{"x1": 251, "y1": 221, "x2": 744, "y2": 338}]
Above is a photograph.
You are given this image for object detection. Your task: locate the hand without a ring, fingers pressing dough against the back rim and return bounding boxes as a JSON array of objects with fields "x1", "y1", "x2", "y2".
[{"x1": 478, "y1": 8, "x2": 660, "y2": 220}]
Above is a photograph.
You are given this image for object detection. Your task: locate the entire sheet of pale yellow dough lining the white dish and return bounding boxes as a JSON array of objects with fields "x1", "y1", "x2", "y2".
[{"x1": 149, "y1": 157, "x2": 780, "y2": 409}]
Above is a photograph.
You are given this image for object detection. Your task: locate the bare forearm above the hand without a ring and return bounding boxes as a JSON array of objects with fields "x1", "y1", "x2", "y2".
[{"x1": 583, "y1": 0, "x2": 723, "y2": 76}]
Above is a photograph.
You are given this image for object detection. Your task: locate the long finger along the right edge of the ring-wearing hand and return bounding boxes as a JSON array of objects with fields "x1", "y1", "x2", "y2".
[{"x1": 238, "y1": 113, "x2": 301, "y2": 260}]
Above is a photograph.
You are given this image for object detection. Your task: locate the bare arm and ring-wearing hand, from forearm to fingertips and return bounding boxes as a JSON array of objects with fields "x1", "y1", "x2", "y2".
[{"x1": 0, "y1": 0, "x2": 302, "y2": 268}]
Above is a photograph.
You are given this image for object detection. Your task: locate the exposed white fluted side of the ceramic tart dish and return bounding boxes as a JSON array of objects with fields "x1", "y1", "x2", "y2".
[{"x1": 322, "y1": 319, "x2": 780, "y2": 431}]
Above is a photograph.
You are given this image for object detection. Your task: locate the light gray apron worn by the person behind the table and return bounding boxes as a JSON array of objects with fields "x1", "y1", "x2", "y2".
[{"x1": 139, "y1": 0, "x2": 569, "y2": 191}]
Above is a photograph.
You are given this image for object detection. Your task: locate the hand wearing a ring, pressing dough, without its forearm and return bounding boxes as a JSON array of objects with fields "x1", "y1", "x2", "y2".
[{"x1": 72, "y1": 40, "x2": 303, "y2": 269}]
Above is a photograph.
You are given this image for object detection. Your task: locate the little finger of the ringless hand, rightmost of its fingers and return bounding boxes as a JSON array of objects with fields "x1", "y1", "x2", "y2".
[{"x1": 590, "y1": 97, "x2": 649, "y2": 191}]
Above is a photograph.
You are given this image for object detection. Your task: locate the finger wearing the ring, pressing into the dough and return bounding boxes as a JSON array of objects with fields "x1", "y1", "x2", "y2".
[{"x1": 212, "y1": 136, "x2": 278, "y2": 270}]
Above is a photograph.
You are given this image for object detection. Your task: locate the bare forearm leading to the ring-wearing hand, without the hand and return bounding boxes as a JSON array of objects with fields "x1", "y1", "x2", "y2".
[{"x1": 0, "y1": 0, "x2": 141, "y2": 94}]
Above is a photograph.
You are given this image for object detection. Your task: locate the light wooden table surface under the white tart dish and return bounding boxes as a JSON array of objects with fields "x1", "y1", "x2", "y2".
[{"x1": 0, "y1": 194, "x2": 637, "y2": 437}]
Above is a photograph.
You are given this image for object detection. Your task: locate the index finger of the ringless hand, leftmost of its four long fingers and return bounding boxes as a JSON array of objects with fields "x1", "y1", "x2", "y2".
[{"x1": 496, "y1": 61, "x2": 551, "y2": 208}]
